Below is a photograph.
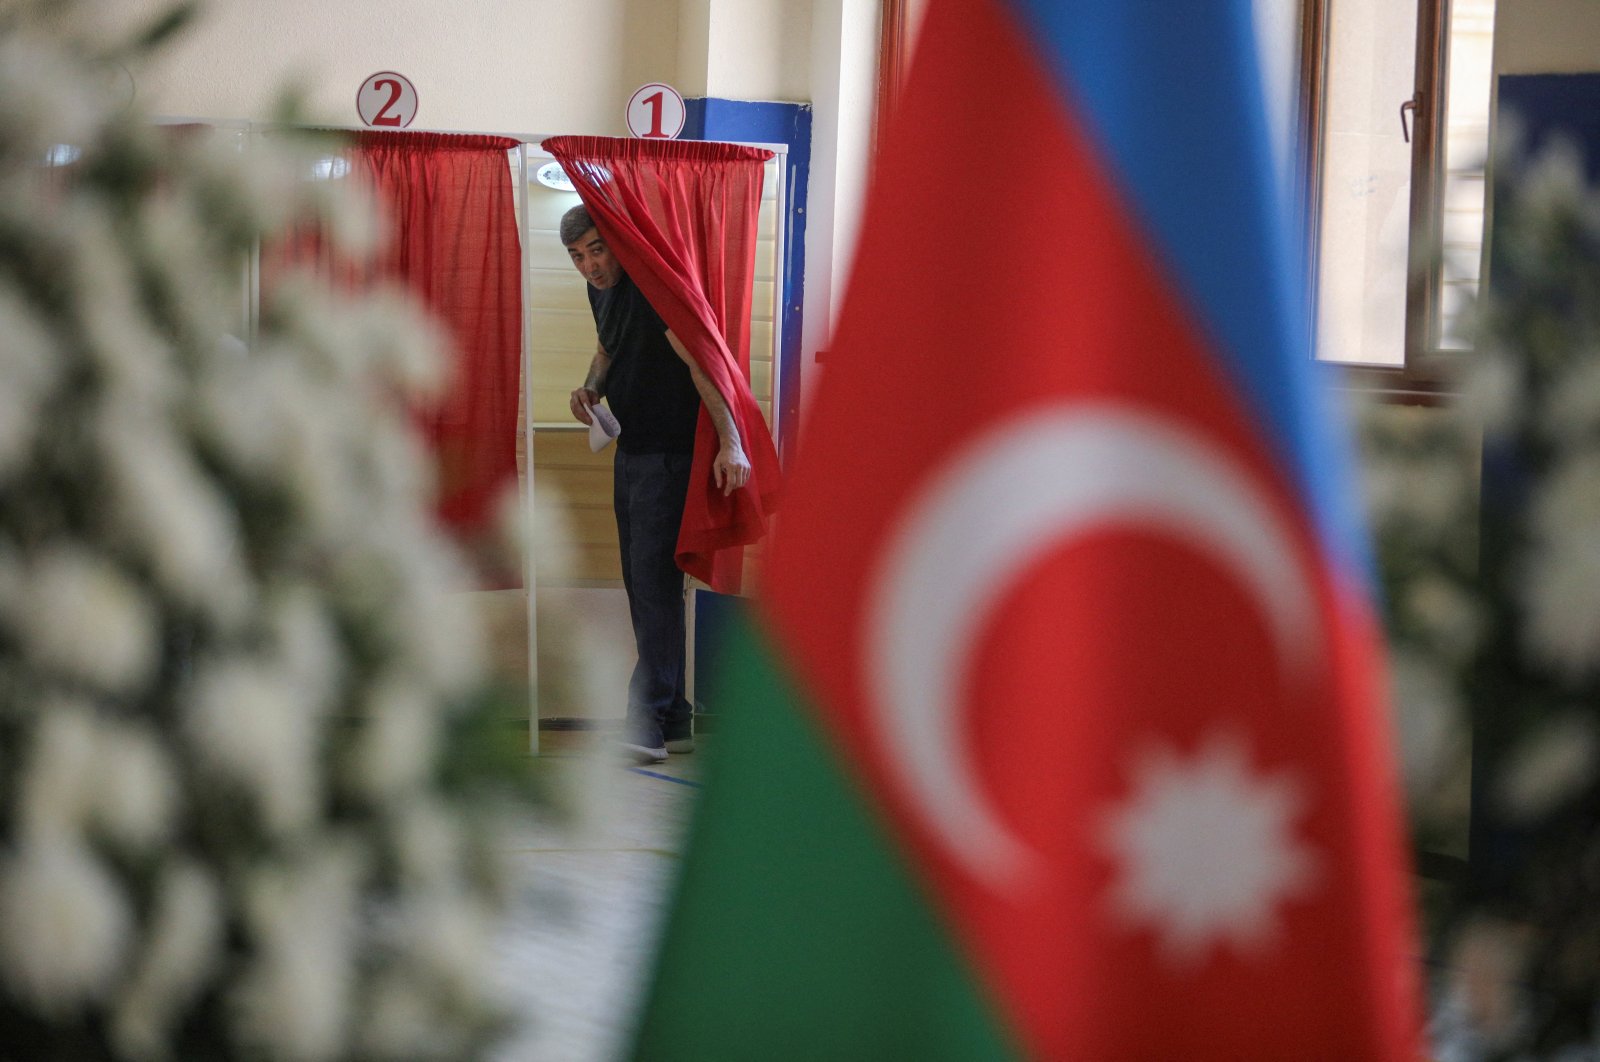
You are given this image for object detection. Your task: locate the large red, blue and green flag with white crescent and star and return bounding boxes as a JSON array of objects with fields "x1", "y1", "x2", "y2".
[{"x1": 634, "y1": 0, "x2": 1418, "y2": 1062}]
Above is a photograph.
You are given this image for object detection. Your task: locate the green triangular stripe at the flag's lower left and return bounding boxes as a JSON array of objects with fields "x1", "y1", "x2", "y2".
[{"x1": 634, "y1": 619, "x2": 1019, "y2": 1062}]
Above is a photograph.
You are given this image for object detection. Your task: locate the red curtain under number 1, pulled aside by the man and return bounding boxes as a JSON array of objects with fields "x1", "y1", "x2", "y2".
[{"x1": 544, "y1": 136, "x2": 778, "y2": 593}]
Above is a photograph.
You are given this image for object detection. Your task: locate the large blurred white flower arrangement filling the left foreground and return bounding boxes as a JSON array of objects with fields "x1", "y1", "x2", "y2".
[{"x1": 0, "y1": 0, "x2": 544, "y2": 1060}]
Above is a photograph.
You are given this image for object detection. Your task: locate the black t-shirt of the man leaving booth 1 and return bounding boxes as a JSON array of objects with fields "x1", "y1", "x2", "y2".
[{"x1": 589, "y1": 273, "x2": 699, "y2": 454}]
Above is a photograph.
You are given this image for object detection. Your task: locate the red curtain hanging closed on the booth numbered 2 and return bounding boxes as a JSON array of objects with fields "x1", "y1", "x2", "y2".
[{"x1": 262, "y1": 133, "x2": 522, "y2": 572}]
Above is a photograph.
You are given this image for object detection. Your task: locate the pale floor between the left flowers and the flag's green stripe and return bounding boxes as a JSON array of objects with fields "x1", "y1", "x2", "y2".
[{"x1": 493, "y1": 733, "x2": 702, "y2": 1062}]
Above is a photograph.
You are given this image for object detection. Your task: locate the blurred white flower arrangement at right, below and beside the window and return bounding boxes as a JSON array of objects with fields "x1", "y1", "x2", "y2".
[{"x1": 1365, "y1": 136, "x2": 1600, "y2": 1062}]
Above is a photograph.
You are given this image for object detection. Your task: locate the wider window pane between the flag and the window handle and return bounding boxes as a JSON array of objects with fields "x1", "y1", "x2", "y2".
[{"x1": 1317, "y1": 0, "x2": 1418, "y2": 366}]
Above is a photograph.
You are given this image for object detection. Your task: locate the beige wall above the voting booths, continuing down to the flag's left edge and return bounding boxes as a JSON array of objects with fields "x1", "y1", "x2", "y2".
[{"x1": 98, "y1": 0, "x2": 880, "y2": 409}]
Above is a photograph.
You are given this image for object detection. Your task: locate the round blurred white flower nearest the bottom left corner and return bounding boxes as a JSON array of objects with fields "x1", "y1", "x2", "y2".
[{"x1": 0, "y1": 838, "x2": 130, "y2": 1017}]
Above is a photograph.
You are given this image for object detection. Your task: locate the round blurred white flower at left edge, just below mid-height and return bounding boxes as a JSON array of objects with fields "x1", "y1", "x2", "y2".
[{"x1": 11, "y1": 545, "x2": 157, "y2": 693}]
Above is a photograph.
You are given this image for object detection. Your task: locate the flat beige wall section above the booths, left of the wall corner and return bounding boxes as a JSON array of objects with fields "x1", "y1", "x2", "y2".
[{"x1": 93, "y1": 0, "x2": 677, "y2": 134}]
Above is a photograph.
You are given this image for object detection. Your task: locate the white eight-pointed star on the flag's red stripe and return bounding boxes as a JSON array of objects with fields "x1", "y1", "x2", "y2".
[{"x1": 1101, "y1": 736, "x2": 1317, "y2": 964}]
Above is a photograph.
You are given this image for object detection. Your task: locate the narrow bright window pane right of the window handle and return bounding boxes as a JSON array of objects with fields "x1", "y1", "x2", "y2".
[{"x1": 1437, "y1": 0, "x2": 1494, "y2": 350}]
